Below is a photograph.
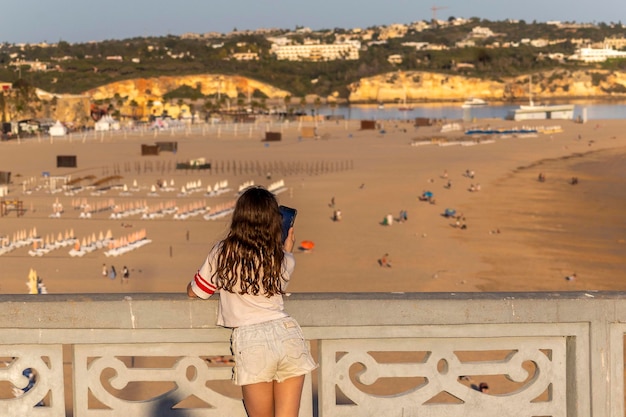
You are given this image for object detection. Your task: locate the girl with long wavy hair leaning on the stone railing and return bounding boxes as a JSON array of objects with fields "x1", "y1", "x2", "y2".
[{"x1": 187, "y1": 187, "x2": 317, "y2": 417}]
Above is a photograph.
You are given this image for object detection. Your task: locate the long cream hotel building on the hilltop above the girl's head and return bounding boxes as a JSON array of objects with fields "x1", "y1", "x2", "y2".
[{"x1": 270, "y1": 40, "x2": 361, "y2": 61}]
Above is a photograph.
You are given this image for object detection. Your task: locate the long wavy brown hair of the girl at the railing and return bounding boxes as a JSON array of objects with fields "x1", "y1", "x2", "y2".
[{"x1": 214, "y1": 187, "x2": 285, "y2": 297}]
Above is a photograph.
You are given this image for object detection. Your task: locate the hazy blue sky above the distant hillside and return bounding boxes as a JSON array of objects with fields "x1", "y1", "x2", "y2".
[{"x1": 0, "y1": 0, "x2": 626, "y2": 43}]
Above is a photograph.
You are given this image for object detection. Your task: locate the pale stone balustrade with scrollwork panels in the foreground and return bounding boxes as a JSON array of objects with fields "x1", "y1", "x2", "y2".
[{"x1": 0, "y1": 292, "x2": 626, "y2": 417}]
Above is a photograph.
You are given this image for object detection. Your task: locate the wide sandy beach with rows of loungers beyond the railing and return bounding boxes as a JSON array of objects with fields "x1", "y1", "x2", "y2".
[{"x1": 0, "y1": 115, "x2": 626, "y2": 294}]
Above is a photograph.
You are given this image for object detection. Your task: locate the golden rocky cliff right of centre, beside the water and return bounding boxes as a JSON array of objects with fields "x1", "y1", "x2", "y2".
[{"x1": 348, "y1": 70, "x2": 626, "y2": 103}]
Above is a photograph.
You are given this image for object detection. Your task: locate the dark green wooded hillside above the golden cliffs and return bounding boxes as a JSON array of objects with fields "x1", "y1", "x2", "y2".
[{"x1": 0, "y1": 18, "x2": 626, "y2": 98}]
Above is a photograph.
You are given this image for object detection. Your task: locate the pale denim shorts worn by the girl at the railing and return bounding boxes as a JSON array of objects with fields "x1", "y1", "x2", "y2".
[{"x1": 231, "y1": 317, "x2": 317, "y2": 385}]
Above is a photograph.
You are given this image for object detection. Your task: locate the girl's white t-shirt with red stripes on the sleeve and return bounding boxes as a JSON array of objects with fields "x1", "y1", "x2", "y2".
[{"x1": 191, "y1": 244, "x2": 296, "y2": 328}]
